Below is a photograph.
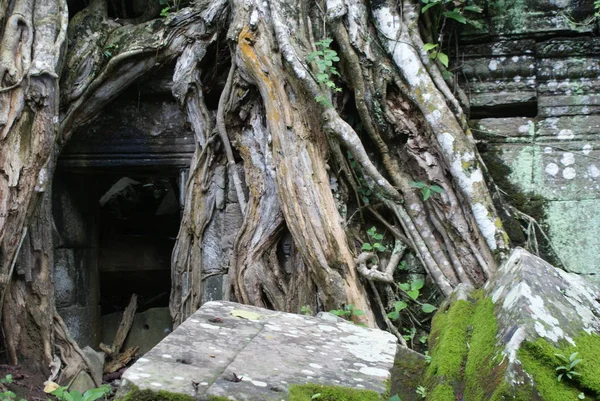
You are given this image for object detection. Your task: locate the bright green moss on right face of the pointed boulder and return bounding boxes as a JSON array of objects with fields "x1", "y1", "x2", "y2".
[{"x1": 517, "y1": 333, "x2": 600, "y2": 401}]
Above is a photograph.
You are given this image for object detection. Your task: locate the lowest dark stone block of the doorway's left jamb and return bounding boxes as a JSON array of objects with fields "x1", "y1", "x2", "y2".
[{"x1": 58, "y1": 306, "x2": 100, "y2": 347}]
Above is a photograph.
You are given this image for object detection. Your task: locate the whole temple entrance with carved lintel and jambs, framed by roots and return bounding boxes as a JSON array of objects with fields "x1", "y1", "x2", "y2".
[{"x1": 53, "y1": 83, "x2": 195, "y2": 352}]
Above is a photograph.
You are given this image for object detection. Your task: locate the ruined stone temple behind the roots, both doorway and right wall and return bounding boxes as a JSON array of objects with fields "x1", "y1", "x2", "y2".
[{"x1": 53, "y1": 0, "x2": 600, "y2": 396}]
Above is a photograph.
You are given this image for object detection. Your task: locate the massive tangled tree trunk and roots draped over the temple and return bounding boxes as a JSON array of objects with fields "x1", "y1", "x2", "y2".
[{"x1": 0, "y1": 0, "x2": 508, "y2": 367}]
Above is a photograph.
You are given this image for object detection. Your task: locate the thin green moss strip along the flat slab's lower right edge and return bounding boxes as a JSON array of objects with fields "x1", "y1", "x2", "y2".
[{"x1": 289, "y1": 384, "x2": 380, "y2": 401}]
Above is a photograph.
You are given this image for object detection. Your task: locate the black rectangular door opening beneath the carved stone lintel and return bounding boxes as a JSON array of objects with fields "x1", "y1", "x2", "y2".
[{"x1": 98, "y1": 176, "x2": 180, "y2": 315}]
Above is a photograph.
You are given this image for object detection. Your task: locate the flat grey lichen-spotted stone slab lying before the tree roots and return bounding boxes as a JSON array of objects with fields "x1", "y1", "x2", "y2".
[{"x1": 119, "y1": 301, "x2": 397, "y2": 401}]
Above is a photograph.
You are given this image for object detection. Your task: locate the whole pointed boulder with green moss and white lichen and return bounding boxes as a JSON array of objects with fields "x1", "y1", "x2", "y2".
[{"x1": 424, "y1": 248, "x2": 600, "y2": 401}]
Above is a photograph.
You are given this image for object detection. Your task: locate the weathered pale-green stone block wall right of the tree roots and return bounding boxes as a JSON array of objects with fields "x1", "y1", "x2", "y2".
[{"x1": 457, "y1": 0, "x2": 600, "y2": 279}]
